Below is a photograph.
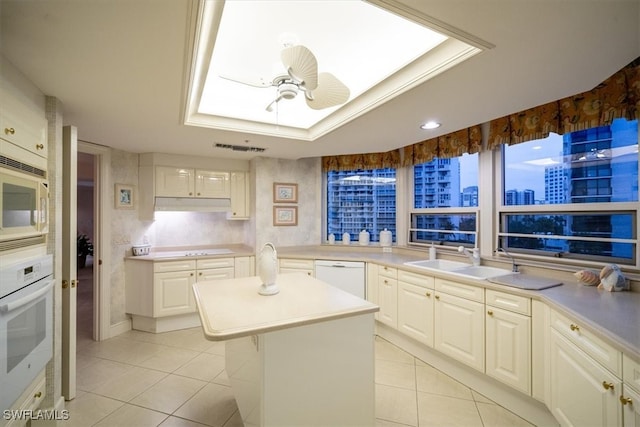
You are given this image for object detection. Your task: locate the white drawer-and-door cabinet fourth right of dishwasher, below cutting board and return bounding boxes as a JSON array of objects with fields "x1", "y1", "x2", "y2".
[{"x1": 485, "y1": 289, "x2": 531, "y2": 394}]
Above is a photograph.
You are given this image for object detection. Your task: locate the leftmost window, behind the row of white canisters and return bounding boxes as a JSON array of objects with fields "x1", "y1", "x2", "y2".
[{"x1": 327, "y1": 168, "x2": 396, "y2": 242}]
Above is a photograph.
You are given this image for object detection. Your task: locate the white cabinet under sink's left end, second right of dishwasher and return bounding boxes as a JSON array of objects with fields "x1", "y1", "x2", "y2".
[{"x1": 398, "y1": 270, "x2": 435, "y2": 347}]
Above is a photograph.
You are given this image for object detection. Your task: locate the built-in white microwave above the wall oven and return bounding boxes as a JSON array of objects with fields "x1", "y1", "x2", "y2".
[{"x1": 0, "y1": 162, "x2": 49, "y2": 252}]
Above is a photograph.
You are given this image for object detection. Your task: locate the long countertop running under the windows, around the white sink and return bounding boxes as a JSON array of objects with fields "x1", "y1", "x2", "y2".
[{"x1": 277, "y1": 245, "x2": 640, "y2": 362}]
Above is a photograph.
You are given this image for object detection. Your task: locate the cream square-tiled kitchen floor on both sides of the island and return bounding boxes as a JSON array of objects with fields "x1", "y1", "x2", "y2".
[{"x1": 71, "y1": 264, "x2": 531, "y2": 427}]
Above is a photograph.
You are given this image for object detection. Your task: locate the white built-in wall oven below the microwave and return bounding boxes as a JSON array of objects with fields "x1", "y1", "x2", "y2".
[{"x1": 0, "y1": 255, "x2": 54, "y2": 408}]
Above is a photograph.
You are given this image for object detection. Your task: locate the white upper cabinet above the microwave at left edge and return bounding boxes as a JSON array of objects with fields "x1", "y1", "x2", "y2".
[{"x1": 0, "y1": 91, "x2": 47, "y2": 170}]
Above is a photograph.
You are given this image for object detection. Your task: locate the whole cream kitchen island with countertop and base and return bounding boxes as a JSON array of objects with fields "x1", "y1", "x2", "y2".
[{"x1": 193, "y1": 273, "x2": 379, "y2": 426}]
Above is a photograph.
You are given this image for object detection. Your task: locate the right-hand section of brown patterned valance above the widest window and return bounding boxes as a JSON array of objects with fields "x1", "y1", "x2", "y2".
[{"x1": 487, "y1": 58, "x2": 640, "y2": 149}]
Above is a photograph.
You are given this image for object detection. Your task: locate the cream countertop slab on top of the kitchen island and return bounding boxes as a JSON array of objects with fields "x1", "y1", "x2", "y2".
[{"x1": 193, "y1": 273, "x2": 380, "y2": 341}]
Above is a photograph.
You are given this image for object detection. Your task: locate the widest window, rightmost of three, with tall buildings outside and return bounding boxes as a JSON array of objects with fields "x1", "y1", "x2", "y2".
[{"x1": 499, "y1": 119, "x2": 638, "y2": 265}]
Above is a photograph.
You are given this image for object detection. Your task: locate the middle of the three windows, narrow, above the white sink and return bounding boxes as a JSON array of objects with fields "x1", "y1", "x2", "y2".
[{"x1": 409, "y1": 154, "x2": 479, "y2": 246}]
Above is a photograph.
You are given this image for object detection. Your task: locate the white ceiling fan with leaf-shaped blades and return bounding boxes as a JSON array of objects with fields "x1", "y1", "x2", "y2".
[{"x1": 220, "y1": 45, "x2": 350, "y2": 111}]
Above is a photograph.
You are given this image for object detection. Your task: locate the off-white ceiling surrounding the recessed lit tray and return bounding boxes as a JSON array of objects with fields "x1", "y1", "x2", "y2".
[{"x1": 0, "y1": 0, "x2": 640, "y2": 159}]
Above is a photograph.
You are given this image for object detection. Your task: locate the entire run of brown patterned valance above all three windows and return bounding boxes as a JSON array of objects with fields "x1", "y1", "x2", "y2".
[{"x1": 322, "y1": 57, "x2": 640, "y2": 172}]
